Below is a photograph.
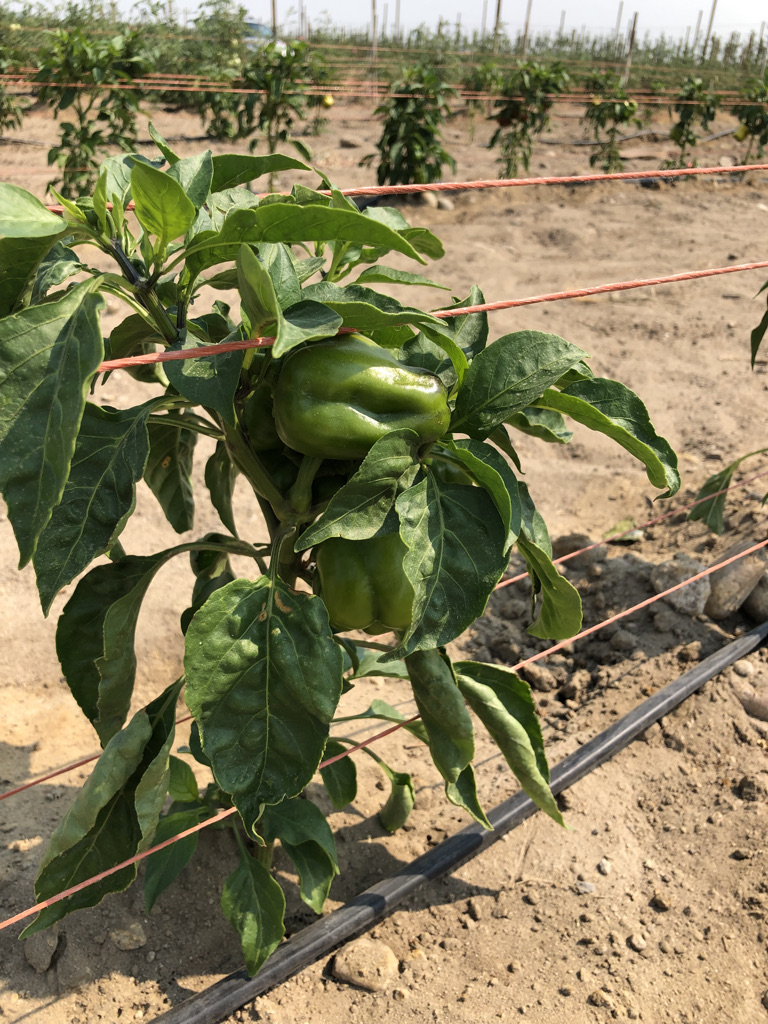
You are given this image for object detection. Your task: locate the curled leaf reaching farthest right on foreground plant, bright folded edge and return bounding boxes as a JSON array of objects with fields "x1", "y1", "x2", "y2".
[{"x1": 534, "y1": 377, "x2": 680, "y2": 498}]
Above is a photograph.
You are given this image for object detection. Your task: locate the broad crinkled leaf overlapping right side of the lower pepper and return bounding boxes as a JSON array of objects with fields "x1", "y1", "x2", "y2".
[{"x1": 397, "y1": 473, "x2": 507, "y2": 658}]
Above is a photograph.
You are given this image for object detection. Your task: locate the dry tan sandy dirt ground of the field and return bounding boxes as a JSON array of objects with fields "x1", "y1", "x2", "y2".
[{"x1": 0, "y1": 97, "x2": 768, "y2": 1024}]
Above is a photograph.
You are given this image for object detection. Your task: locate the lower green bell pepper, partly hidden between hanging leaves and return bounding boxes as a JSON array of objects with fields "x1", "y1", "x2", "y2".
[{"x1": 314, "y1": 534, "x2": 414, "y2": 636}]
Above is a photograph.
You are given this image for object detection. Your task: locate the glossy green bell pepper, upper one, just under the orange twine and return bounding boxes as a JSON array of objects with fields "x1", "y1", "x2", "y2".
[{"x1": 273, "y1": 334, "x2": 451, "y2": 459}]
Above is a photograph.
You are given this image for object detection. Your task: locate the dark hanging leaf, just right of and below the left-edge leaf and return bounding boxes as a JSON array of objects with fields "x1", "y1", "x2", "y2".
[{"x1": 34, "y1": 398, "x2": 162, "y2": 614}]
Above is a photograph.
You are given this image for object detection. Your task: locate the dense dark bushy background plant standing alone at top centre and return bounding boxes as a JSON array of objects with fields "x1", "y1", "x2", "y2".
[{"x1": 360, "y1": 65, "x2": 456, "y2": 185}]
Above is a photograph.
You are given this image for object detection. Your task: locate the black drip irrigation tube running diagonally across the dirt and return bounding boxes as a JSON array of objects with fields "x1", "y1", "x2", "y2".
[{"x1": 156, "y1": 622, "x2": 768, "y2": 1024}]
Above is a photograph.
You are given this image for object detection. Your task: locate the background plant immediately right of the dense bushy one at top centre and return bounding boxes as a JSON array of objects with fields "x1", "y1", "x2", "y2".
[{"x1": 488, "y1": 60, "x2": 570, "y2": 178}]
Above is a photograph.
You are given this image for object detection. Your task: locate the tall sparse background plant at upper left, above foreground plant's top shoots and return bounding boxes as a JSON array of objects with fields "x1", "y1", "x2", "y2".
[{"x1": 36, "y1": 28, "x2": 153, "y2": 199}]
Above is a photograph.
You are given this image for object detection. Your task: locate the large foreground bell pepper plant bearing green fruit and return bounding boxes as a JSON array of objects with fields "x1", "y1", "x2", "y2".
[{"x1": 0, "y1": 138, "x2": 680, "y2": 973}]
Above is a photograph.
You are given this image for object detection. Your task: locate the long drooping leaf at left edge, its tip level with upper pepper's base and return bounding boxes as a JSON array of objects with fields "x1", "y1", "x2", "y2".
[{"x1": 0, "y1": 282, "x2": 103, "y2": 566}]
